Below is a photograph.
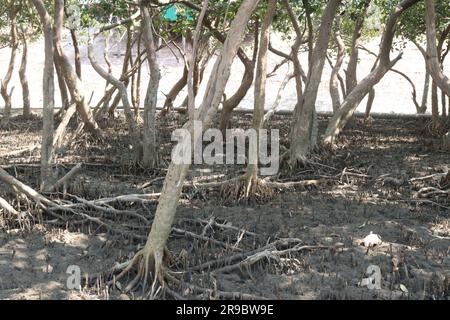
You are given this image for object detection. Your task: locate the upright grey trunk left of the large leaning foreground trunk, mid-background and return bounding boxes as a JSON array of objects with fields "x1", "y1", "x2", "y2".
[{"x1": 140, "y1": 5, "x2": 161, "y2": 168}]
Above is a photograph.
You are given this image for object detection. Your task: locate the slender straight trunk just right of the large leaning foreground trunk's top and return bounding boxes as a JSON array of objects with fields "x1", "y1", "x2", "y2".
[{"x1": 246, "y1": 0, "x2": 277, "y2": 190}]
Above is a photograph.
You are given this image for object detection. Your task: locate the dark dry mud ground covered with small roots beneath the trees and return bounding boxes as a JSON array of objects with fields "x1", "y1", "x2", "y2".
[{"x1": 0, "y1": 115, "x2": 450, "y2": 300}]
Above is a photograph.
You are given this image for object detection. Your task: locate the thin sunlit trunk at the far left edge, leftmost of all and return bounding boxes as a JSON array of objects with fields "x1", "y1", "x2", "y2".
[{"x1": 0, "y1": 4, "x2": 18, "y2": 125}]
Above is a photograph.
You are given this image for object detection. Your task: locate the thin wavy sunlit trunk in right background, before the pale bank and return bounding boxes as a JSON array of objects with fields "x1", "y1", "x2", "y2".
[{"x1": 330, "y1": 15, "x2": 345, "y2": 112}]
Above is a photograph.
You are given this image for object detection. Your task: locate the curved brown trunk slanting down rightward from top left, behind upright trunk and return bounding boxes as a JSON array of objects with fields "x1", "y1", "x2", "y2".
[{"x1": 55, "y1": 0, "x2": 101, "y2": 136}]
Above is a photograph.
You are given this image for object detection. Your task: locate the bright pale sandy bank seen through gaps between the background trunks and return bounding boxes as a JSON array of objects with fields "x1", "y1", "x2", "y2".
[{"x1": 0, "y1": 34, "x2": 450, "y2": 114}]
